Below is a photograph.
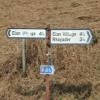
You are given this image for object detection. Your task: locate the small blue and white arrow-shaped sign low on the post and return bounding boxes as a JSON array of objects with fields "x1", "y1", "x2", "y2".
[{"x1": 40, "y1": 65, "x2": 55, "y2": 75}]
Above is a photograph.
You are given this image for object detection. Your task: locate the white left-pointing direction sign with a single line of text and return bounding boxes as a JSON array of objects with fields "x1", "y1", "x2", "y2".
[{"x1": 7, "y1": 28, "x2": 46, "y2": 39}]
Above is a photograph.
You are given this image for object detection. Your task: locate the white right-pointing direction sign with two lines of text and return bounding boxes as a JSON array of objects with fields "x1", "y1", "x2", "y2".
[{"x1": 51, "y1": 29, "x2": 93, "y2": 44}]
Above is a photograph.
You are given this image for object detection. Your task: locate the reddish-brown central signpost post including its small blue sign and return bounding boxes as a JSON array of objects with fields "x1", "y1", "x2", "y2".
[{"x1": 40, "y1": 26, "x2": 55, "y2": 100}]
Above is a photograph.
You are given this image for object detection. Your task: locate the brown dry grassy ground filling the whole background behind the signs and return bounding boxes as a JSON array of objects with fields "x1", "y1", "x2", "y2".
[{"x1": 0, "y1": 0, "x2": 100, "y2": 100}]
